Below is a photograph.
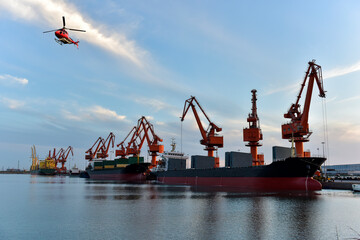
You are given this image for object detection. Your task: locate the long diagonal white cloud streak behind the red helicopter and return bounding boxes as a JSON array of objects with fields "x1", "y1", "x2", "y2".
[{"x1": 0, "y1": 0, "x2": 147, "y2": 67}]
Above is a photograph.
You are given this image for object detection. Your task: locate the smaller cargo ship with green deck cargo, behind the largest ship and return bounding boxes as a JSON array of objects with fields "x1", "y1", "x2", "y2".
[{"x1": 86, "y1": 157, "x2": 150, "y2": 183}]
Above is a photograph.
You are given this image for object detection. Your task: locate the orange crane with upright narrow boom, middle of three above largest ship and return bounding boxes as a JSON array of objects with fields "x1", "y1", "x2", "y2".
[{"x1": 243, "y1": 89, "x2": 264, "y2": 166}]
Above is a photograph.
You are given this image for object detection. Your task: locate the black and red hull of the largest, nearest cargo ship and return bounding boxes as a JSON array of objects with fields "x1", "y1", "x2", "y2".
[{"x1": 154, "y1": 157, "x2": 326, "y2": 191}]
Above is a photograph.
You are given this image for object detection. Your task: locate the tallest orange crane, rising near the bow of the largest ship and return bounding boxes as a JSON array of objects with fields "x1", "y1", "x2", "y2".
[{"x1": 281, "y1": 60, "x2": 325, "y2": 157}]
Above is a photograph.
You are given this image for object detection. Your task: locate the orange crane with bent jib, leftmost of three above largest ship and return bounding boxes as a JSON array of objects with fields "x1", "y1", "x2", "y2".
[{"x1": 181, "y1": 96, "x2": 224, "y2": 168}]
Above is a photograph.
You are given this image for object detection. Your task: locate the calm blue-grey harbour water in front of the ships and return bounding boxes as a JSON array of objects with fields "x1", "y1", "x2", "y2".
[{"x1": 0, "y1": 174, "x2": 360, "y2": 240}]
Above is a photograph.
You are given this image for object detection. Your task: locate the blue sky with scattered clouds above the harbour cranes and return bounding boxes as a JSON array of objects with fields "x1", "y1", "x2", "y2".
[{"x1": 0, "y1": 0, "x2": 360, "y2": 169}]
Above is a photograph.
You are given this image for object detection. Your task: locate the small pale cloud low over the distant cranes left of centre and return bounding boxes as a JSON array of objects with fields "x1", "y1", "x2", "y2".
[{"x1": 63, "y1": 105, "x2": 126, "y2": 122}]
